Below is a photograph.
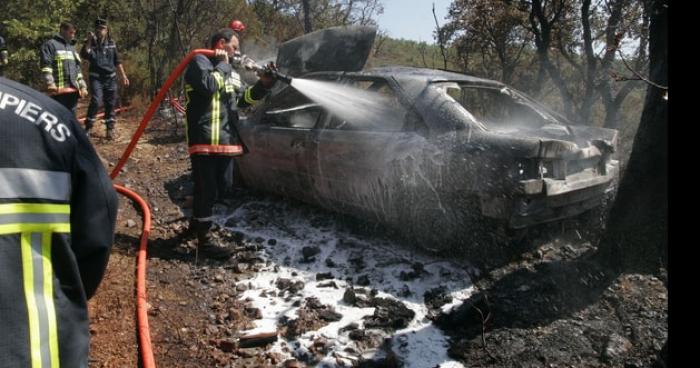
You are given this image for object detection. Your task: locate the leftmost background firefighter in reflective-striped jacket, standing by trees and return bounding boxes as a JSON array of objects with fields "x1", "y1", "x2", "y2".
[{"x1": 40, "y1": 22, "x2": 87, "y2": 114}]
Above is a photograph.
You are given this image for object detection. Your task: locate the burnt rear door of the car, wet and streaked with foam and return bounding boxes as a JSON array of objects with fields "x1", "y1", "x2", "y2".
[{"x1": 313, "y1": 78, "x2": 426, "y2": 222}]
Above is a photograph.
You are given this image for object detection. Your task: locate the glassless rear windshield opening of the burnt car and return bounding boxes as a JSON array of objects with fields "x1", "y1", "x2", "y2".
[{"x1": 433, "y1": 82, "x2": 559, "y2": 131}]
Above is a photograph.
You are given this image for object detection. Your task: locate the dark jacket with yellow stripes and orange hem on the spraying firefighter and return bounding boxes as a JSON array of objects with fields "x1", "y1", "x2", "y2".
[{"x1": 185, "y1": 55, "x2": 267, "y2": 156}]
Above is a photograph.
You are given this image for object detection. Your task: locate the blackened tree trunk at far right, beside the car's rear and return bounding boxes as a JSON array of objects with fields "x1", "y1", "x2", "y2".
[{"x1": 599, "y1": 0, "x2": 668, "y2": 273}]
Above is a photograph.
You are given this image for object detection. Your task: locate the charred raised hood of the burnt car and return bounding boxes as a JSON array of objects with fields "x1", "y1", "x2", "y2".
[{"x1": 276, "y1": 26, "x2": 377, "y2": 77}]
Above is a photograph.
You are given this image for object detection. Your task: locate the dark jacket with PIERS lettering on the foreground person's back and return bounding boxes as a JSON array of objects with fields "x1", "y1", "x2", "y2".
[{"x1": 0, "y1": 77, "x2": 117, "y2": 368}]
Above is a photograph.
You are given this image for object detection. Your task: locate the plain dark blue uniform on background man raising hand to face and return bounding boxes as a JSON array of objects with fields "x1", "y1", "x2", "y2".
[{"x1": 80, "y1": 38, "x2": 121, "y2": 129}]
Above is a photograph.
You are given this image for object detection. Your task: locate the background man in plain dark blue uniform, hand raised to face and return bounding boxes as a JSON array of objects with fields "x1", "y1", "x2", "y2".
[{"x1": 80, "y1": 18, "x2": 129, "y2": 140}]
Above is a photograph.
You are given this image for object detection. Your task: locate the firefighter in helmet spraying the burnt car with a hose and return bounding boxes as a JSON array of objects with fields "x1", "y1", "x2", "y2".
[{"x1": 185, "y1": 28, "x2": 275, "y2": 259}]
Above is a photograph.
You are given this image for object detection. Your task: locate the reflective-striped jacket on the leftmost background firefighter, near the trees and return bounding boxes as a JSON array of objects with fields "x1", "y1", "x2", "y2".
[{"x1": 40, "y1": 35, "x2": 87, "y2": 89}]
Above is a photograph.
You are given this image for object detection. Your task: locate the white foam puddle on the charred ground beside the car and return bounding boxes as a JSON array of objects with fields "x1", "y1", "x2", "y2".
[{"x1": 221, "y1": 201, "x2": 473, "y2": 368}]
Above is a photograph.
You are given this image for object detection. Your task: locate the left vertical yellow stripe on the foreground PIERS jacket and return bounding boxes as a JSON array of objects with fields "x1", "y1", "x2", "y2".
[{"x1": 21, "y1": 231, "x2": 41, "y2": 368}]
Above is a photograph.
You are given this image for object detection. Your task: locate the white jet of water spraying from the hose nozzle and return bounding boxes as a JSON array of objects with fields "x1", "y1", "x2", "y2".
[{"x1": 292, "y1": 78, "x2": 405, "y2": 130}]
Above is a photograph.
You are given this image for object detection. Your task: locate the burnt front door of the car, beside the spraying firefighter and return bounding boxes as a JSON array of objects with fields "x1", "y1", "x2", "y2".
[{"x1": 238, "y1": 88, "x2": 323, "y2": 200}]
